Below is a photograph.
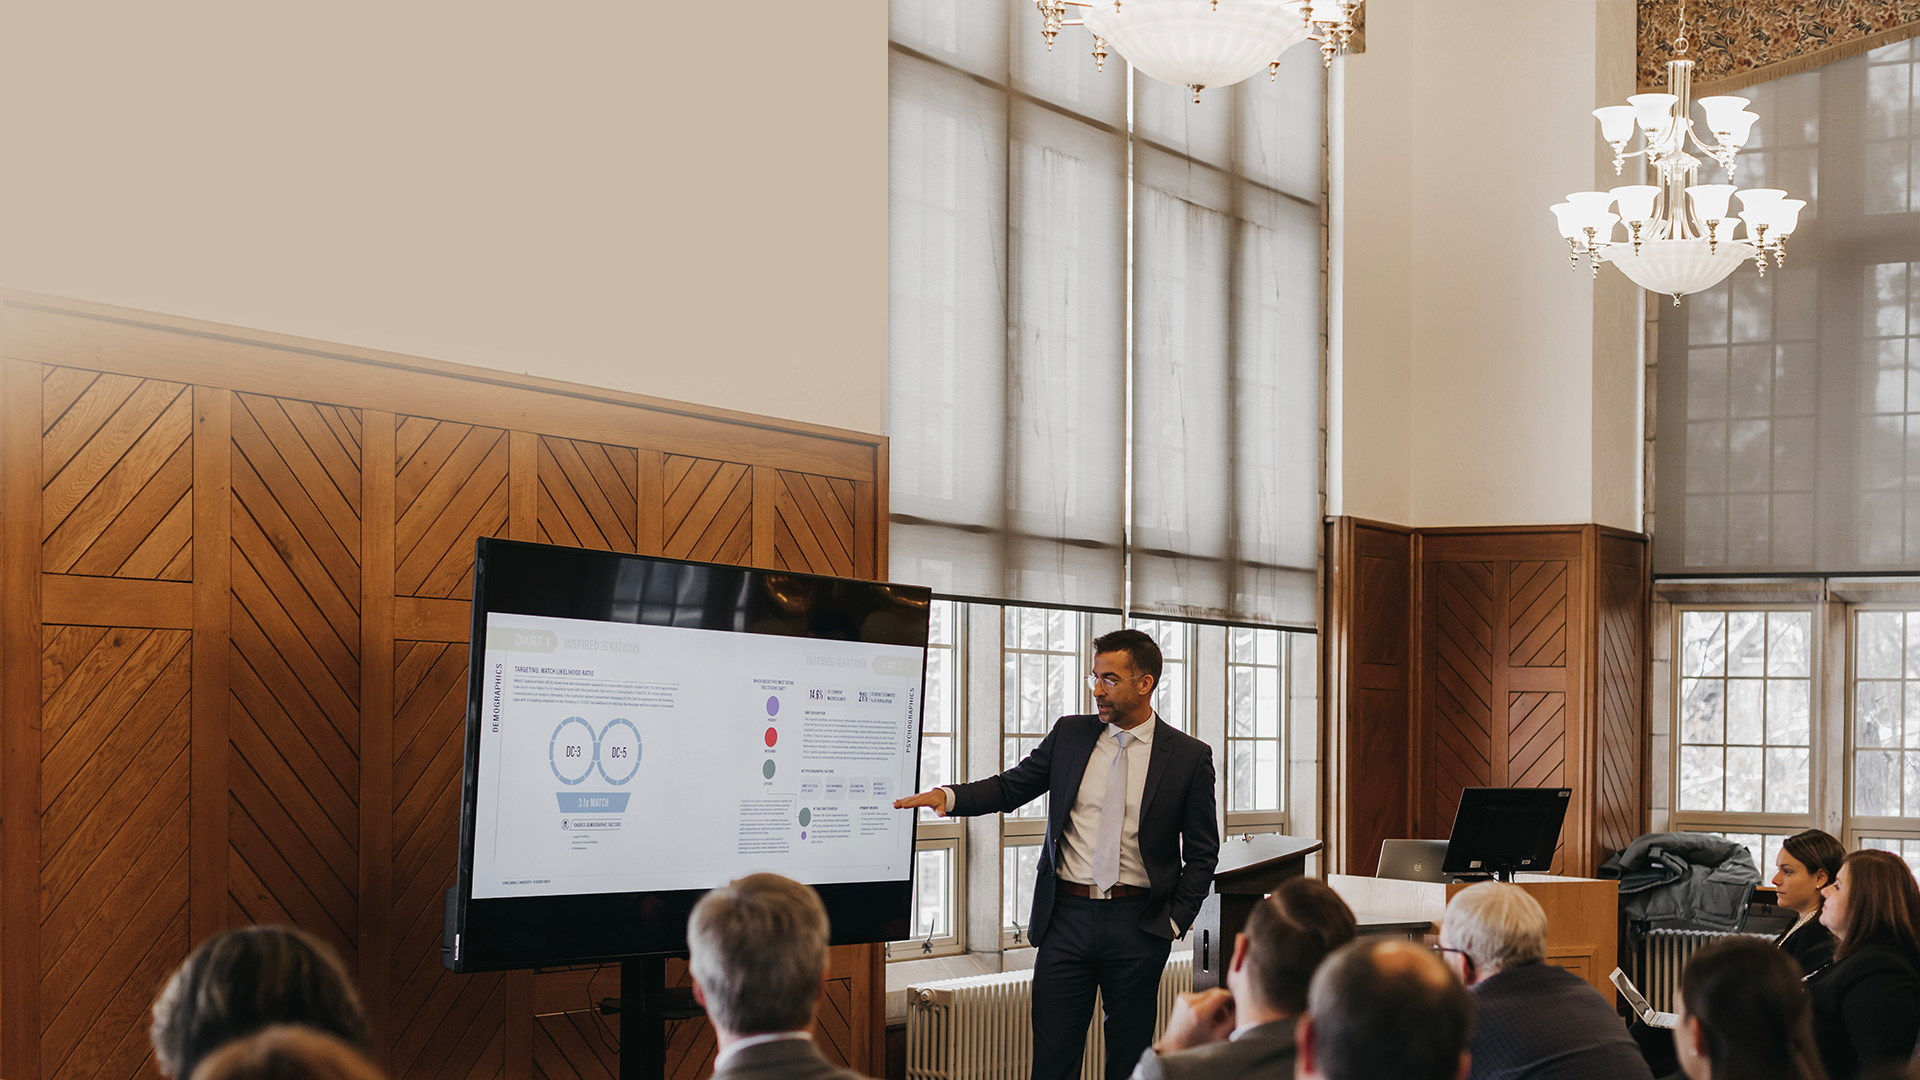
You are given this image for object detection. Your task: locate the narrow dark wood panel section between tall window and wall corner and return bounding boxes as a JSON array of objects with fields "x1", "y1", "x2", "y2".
[{"x1": 1321, "y1": 517, "x2": 1415, "y2": 874}]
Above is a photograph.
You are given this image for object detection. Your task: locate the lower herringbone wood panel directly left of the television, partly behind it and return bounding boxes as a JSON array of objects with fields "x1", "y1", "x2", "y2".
[{"x1": 392, "y1": 642, "x2": 505, "y2": 1078}]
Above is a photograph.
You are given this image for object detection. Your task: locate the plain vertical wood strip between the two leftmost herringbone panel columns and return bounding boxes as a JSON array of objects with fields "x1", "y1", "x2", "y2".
[{"x1": 188, "y1": 386, "x2": 234, "y2": 944}]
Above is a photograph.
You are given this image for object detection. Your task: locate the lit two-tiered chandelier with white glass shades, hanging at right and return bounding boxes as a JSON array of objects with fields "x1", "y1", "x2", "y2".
[{"x1": 1553, "y1": 8, "x2": 1807, "y2": 304}]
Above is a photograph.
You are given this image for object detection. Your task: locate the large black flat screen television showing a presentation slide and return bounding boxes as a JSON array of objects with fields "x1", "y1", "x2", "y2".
[{"x1": 442, "y1": 538, "x2": 931, "y2": 972}]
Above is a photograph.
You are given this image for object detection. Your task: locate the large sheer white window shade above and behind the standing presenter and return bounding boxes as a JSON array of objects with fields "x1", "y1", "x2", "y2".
[{"x1": 889, "y1": 0, "x2": 1323, "y2": 625}]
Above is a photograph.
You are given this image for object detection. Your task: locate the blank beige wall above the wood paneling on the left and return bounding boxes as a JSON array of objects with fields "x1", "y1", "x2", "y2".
[{"x1": 0, "y1": 0, "x2": 887, "y2": 432}]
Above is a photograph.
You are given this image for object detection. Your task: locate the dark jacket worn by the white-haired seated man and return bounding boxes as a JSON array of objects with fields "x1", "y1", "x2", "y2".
[{"x1": 1467, "y1": 963, "x2": 1653, "y2": 1080}]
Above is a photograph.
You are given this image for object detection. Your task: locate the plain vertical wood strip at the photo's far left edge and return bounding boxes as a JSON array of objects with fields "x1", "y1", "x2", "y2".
[{"x1": 0, "y1": 355, "x2": 42, "y2": 1080}]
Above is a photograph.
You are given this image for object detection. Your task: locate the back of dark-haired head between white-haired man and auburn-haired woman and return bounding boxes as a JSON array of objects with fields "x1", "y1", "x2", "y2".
[{"x1": 1674, "y1": 938, "x2": 1824, "y2": 1080}]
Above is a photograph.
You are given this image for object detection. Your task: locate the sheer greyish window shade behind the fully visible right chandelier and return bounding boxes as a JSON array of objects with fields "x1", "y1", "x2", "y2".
[{"x1": 1653, "y1": 42, "x2": 1920, "y2": 575}]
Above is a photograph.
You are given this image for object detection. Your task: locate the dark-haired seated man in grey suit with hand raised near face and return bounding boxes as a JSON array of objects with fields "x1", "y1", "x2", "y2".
[{"x1": 1133, "y1": 878, "x2": 1356, "y2": 1080}]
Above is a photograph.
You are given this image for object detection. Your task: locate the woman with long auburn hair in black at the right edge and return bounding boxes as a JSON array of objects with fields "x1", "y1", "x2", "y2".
[{"x1": 1807, "y1": 849, "x2": 1920, "y2": 1080}]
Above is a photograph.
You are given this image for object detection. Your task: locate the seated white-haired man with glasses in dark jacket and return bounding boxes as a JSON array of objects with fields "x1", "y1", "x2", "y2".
[{"x1": 1440, "y1": 882, "x2": 1653, "y2": 1080}]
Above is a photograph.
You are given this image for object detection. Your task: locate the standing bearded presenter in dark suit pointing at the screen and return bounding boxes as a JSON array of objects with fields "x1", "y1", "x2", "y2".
[{"x1": 893, "y1": 630, "x2": 1219, "y2": 1080}]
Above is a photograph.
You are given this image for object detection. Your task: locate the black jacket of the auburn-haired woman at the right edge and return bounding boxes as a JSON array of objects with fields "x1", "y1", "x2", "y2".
[{"x1": 1807, "y1": 933, "x2": 1920, "y2": 1080}]
